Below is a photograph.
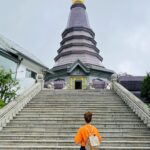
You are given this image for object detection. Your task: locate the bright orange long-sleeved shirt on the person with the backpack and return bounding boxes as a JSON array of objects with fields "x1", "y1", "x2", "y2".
[{"x1": 74, "y1": 124, "x2": 102, "y2": 146}]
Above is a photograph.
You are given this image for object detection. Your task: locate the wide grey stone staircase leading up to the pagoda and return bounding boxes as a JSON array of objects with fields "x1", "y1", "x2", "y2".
[{"x1": 0, "y1": 90, "x2": 150, "y2": 150}]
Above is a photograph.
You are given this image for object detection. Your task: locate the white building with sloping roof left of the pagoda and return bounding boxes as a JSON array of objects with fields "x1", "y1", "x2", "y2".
[{"x1": 0, "y1": 35, "x2": 48, "y2": 79}]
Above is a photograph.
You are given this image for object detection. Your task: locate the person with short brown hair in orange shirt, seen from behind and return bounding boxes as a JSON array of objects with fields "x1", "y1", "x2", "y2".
[{"x1": 74, "y1": 112, "x2": 102, "y2": 150}]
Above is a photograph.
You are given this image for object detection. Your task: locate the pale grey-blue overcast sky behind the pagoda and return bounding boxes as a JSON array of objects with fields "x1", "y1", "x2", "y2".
[{"x1": 0, "y1": 0, "x2": 150, "y2": 75}]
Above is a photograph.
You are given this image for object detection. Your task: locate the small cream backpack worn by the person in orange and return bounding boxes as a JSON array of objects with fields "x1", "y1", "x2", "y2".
[{"x1": 85, "y1": 127, "x2": 100, "y2": 150}]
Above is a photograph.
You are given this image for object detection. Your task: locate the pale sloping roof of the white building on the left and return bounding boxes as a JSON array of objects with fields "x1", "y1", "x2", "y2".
[{"x1": 0, "y1": 34, "x2": 48, "y2": 68}]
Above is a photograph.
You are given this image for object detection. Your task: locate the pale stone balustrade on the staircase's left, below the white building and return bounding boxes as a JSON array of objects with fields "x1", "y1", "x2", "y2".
[{"x1": 0, "y1": 82, "x2": 42, "y2": 130}]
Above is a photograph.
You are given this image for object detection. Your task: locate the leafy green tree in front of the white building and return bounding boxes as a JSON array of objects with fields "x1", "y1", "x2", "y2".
[{"x1": 0, "y1": 69, "x2": 19, "y2": 104}]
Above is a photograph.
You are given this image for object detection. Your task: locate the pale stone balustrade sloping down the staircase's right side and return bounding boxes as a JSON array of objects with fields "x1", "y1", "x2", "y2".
[{"x1": 112, "y1": 80, "x2": 150, "y2": 127}]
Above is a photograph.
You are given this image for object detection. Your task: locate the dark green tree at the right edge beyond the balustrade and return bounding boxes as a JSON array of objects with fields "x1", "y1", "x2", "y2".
[{"x1": 141, "y1": 74, "x2": 150, "y2": 101}]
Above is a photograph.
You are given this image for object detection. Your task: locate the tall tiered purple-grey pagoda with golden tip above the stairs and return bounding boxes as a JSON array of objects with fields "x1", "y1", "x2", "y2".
[{"x1": 46, "y1": 0, "x2": 114, "y2": 89}]
